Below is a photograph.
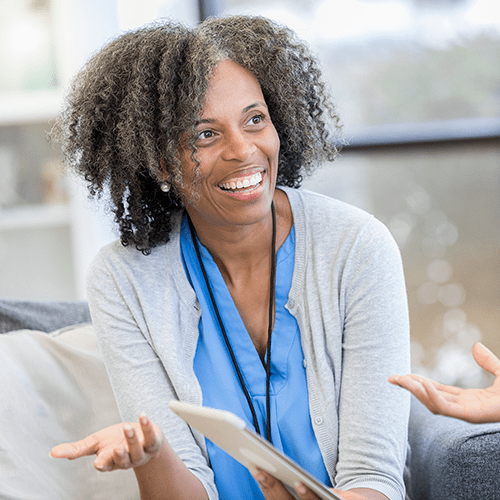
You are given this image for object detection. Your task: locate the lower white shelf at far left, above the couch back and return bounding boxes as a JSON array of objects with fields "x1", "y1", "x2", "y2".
[{"x1": 0, "y1": 205, "x2": 71, "y2": 231}]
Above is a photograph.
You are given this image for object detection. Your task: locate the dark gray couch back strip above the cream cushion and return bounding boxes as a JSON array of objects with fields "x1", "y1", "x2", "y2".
[{"x1": 0, "y1": 300, "x2": 90, "y2": 333}]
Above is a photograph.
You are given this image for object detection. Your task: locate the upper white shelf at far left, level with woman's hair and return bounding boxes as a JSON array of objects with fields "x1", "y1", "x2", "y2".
[{"x1": 0, "y1": 90, "x2": 63, "y2": 127}]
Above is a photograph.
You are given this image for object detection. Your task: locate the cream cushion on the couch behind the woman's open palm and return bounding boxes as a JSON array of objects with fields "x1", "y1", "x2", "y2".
[{"x1": 0, "y1": 324, "x2": 139, "y2": 500}]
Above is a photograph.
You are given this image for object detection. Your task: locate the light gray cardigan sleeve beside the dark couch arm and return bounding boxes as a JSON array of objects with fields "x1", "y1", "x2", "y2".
[{"x1": 336, "y1": 218, "x2": 410, "y2": 500}]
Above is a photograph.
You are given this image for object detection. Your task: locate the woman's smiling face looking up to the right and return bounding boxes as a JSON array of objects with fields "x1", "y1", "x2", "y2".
[{"x1": 179, "y1": 60, "x2": 280, "y2": 226}]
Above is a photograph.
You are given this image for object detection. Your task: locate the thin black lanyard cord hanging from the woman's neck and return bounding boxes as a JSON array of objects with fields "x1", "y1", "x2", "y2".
[{"x1": 188, "y1": 203, "x2": 276, "y2": 441}]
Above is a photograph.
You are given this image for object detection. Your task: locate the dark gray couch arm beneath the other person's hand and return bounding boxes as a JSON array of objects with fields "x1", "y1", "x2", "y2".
[{"x1": 409, "y1": 398, "x2": 500, "y2": 500}]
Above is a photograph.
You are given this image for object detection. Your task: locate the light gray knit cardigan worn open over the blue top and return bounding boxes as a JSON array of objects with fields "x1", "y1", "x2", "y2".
[{"x1": 88, "y1": 188, "x2": 410, "y2": 500}]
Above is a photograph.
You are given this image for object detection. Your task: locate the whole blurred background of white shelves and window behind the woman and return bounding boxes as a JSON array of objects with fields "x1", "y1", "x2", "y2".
[{"x1": 0, "y1": 0, "x2": 500, "y2": 386}]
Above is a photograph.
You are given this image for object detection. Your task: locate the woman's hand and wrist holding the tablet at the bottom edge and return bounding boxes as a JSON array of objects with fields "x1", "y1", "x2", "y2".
[{"x1": 254, "y1": 470, "x2": 387, "y2": 500}]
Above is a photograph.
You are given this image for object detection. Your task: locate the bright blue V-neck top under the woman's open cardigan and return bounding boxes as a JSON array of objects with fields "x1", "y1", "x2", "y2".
[{"x1": 181, "y1": 216, "x2": 331, "y2": 500}]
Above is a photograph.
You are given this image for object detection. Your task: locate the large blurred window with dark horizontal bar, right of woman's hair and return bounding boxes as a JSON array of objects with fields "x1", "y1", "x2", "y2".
[{"x1": 206, "y1": 0, "x2": 500, "y2": 385}]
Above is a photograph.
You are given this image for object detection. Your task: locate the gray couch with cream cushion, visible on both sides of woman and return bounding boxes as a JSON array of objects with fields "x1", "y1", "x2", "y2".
[{"x1": 0, "y1": 300, "x2": 500, "y2": 500}]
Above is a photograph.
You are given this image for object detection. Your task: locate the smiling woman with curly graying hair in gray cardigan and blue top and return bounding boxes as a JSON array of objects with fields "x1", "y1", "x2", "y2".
[{"x1": 52, "y1": 16, "x2": 409, "y2": 500}]
